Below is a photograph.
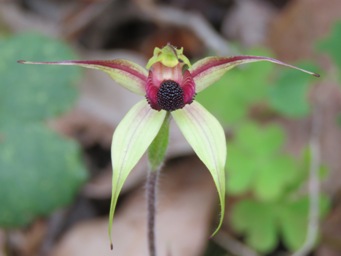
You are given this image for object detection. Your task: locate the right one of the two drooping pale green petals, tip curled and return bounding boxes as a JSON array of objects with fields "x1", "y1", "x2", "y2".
[{"x1": 172, "y1": 101, "x2": 226, "y2": 235}]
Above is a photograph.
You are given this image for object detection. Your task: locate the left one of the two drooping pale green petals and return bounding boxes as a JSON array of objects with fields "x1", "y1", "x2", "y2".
[{"x1": 109, "y1": 100, "x2": 167, "y2": 246}]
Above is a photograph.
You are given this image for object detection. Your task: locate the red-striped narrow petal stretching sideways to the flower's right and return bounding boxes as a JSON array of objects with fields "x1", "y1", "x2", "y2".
[{"x1": 189, "y1": 56, "x2": 319, "y2": 92}]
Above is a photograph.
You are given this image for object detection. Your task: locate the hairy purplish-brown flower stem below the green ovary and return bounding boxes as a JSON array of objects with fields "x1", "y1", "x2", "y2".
[{"x1": 147, "y1": 170, "x2": 159, "y2": 256}]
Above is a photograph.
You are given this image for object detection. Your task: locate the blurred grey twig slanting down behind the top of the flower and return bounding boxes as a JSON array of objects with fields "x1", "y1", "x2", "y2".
[{"x1": 135, "y1": 1, "x2": 236, "y2": 55}]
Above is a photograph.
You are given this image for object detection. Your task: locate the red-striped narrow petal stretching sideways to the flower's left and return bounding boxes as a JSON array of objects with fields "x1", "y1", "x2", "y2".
[{"x1": 18, "y1": 59, "x2": 148, "y2": 95}]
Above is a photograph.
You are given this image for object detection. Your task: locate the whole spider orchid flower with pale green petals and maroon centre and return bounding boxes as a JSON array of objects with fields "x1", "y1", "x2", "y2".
[{"x1": 19, "y1": 44, "x2": 318, "y2": 248}]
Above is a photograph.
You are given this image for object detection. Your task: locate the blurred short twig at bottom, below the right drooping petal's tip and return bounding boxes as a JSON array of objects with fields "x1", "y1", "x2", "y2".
[{"x1": 213, "y1": 230, "x2": 258, "y2": 256}]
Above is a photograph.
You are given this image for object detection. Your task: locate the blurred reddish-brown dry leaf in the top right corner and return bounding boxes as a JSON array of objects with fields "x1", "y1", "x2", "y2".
[{"x1": 269, "y1": 0, "x2": 341, "y2": 61}]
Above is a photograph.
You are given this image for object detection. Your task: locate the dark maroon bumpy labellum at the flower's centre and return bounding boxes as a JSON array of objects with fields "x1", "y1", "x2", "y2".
[{"x1": 157, "y1": 80, "x2": 185, "y2": 111}]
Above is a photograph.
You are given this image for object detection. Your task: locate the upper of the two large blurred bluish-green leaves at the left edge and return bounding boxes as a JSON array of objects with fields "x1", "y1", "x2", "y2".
[{"x1": 0, "y1": 33, "x2": 80, "y2": 123}]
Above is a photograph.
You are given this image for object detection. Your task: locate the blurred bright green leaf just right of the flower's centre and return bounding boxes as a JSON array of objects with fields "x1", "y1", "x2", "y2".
[{"x1": 196, "y1": 60, "x2": 273, "y2": 124}]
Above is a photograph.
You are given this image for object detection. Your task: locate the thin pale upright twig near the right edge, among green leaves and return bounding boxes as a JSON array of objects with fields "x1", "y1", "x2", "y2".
[{"x1": 292, "y1": 88, "x2": 323, "y2": 256}]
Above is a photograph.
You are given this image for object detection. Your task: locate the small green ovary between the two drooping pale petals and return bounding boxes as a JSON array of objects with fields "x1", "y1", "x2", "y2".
[{"x1": 148, "y1": 113, "x2": 170, "y2": 171}]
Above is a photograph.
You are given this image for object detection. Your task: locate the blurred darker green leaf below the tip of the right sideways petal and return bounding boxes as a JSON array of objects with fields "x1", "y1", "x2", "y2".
[{"x1": 268, "y1": 65, "x2": 316, "y2": 117}]
